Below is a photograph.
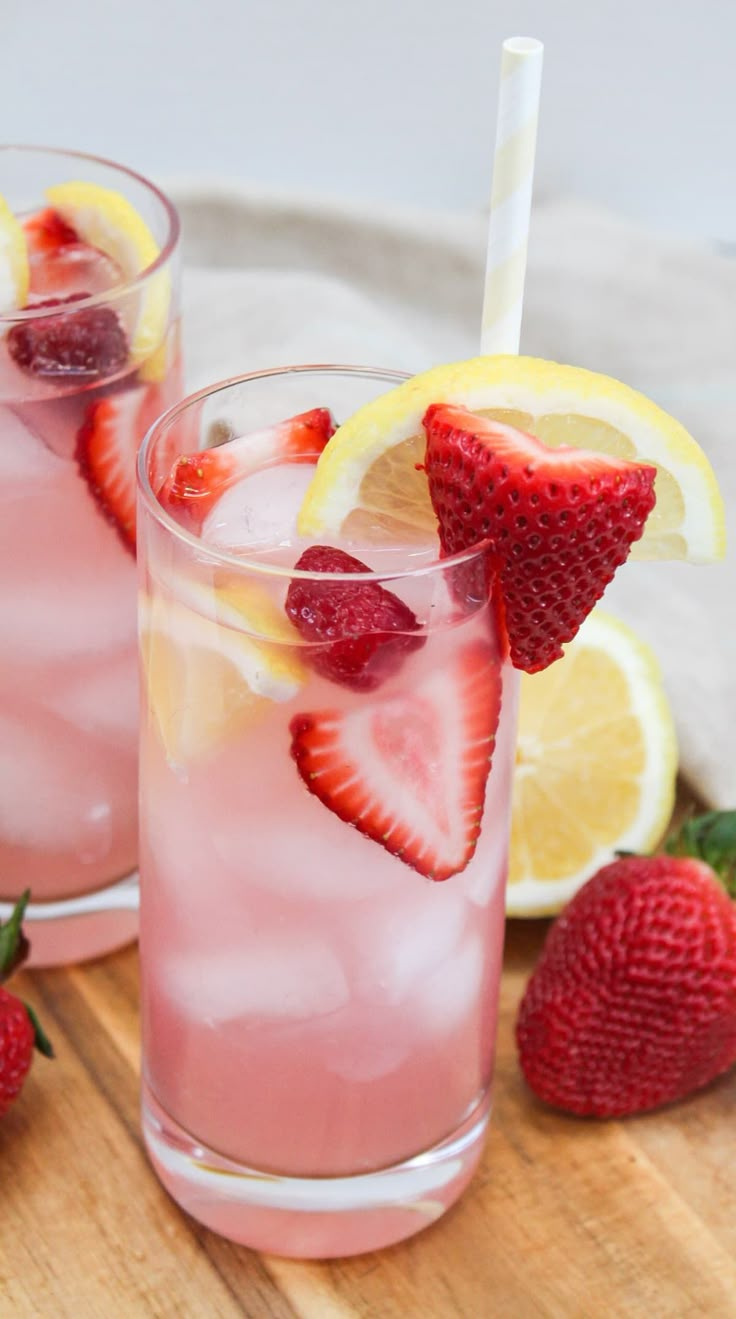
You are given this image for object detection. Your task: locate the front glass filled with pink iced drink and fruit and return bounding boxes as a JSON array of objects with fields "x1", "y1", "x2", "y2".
[{"x1": 138, "y1": 368, "x2": 516, "y2": 1257}]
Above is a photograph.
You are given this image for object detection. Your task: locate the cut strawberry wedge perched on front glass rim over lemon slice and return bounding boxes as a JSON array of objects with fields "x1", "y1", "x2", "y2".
[{"x1": 423, "y1": 404, "x2": 656, "y2": 673}]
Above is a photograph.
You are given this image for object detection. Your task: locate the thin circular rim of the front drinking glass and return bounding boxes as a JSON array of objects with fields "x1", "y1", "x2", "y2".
[{"x1": 136, "y1": 363, "x2": 489, "y2": 582}]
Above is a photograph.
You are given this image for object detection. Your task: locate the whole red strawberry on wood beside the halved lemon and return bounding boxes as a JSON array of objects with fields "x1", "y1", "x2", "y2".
[{"x1": 516, "y1": 811, "x2": 736, "y2": 1117}]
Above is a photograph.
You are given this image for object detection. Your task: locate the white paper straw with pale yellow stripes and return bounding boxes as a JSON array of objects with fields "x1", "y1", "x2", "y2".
[{"x1": 480, "y1": 37, "x2": 545, "y2": 353}]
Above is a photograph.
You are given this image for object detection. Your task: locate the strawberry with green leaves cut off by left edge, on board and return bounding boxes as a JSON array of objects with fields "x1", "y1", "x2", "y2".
[{"x1": 0, "y1": 892, "x2": 54, "y2": 1117}]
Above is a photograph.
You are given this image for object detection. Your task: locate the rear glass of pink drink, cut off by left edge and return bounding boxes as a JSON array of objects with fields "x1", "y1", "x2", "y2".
[{"x1": 0, "y1": 148, "x2": 181, "y2": 964}]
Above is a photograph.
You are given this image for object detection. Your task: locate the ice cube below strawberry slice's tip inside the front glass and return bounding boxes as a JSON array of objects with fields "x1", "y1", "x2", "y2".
[{"x1": 351, "y1": 869, "x2": 468, "y2": 1004}]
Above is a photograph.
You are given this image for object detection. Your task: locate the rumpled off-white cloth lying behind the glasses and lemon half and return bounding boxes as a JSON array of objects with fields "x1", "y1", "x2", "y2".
[{"x1": 169, "y1": 181, "x2": 736, "y2": 807}]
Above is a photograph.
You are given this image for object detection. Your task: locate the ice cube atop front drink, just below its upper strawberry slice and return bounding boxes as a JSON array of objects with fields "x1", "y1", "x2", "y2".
[{"x1": 202, "y1": 463, "x2": 314, "y2": 549}]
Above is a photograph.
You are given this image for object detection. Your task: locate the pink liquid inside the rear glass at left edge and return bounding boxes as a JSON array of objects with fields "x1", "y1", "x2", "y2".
[{"x1": 0, "y1": 218, "x2": 178, "y2": 962}]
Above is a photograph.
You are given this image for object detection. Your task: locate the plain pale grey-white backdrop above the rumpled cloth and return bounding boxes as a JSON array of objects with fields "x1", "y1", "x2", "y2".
[{"x1": 0, "y1": 0, "x2": 736, "y2": 244}]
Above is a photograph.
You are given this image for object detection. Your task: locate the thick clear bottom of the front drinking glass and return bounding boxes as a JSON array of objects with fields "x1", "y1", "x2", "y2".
[{"x1": 142, "y1": 1083, "x2": 491, "y2": 1260}]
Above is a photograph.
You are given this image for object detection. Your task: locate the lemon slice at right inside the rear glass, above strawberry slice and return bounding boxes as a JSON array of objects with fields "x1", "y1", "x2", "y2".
[{"x1": 46, "y1": 182, "x2": 171, "y2": 380}]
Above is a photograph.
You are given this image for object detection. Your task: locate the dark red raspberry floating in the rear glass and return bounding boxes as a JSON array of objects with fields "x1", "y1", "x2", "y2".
[{"x1": 8, "y1": 293, "x2": 128, "y2": 384}]
